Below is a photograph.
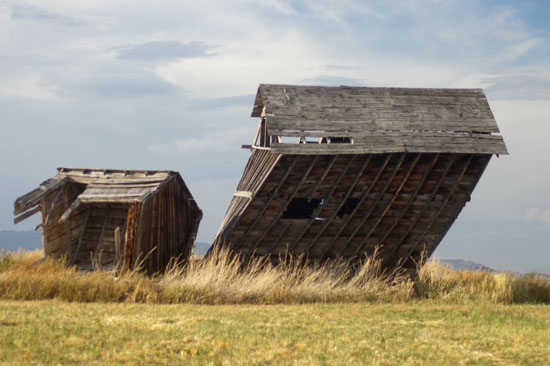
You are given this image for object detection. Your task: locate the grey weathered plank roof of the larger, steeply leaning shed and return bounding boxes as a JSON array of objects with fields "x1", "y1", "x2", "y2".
[{"x1": 252, "y1": 84, "x2": 508, "y2": 155}]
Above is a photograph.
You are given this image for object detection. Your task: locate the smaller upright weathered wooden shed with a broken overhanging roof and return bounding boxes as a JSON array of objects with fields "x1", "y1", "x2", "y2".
[{"x1": 14, "y1": 168, "x2": 202, "y2": 272}]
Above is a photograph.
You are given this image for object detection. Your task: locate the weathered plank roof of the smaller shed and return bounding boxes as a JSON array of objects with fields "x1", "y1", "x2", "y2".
[{"x1": 14, "y1": 167, "x2": 196, "y2": 223}]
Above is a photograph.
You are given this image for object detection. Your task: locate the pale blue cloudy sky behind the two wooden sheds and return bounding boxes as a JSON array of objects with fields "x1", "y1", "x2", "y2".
[{"x1": 0, "y1": 0, "x2": 550, "y2": 273}]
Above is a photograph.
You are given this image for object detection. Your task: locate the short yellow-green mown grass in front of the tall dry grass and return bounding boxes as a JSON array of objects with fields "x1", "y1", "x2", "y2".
[{"x1": 0, "y1": 300, "x2": 550, "y2": 365}]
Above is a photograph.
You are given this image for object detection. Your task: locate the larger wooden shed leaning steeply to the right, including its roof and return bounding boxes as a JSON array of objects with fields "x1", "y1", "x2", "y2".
[{"x1": 212, "y1": 85, "x2": 507, "y2": 268}]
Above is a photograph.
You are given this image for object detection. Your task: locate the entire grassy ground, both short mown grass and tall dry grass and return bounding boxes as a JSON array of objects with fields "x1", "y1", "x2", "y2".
[{"x1": 0, "y1": 252, "x2": 550, "y2": 366}]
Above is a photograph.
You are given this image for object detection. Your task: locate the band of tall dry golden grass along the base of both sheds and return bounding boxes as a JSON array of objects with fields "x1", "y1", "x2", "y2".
[{"x1": 0, "y1": 250, "x2": 550, "y2": 304}]
